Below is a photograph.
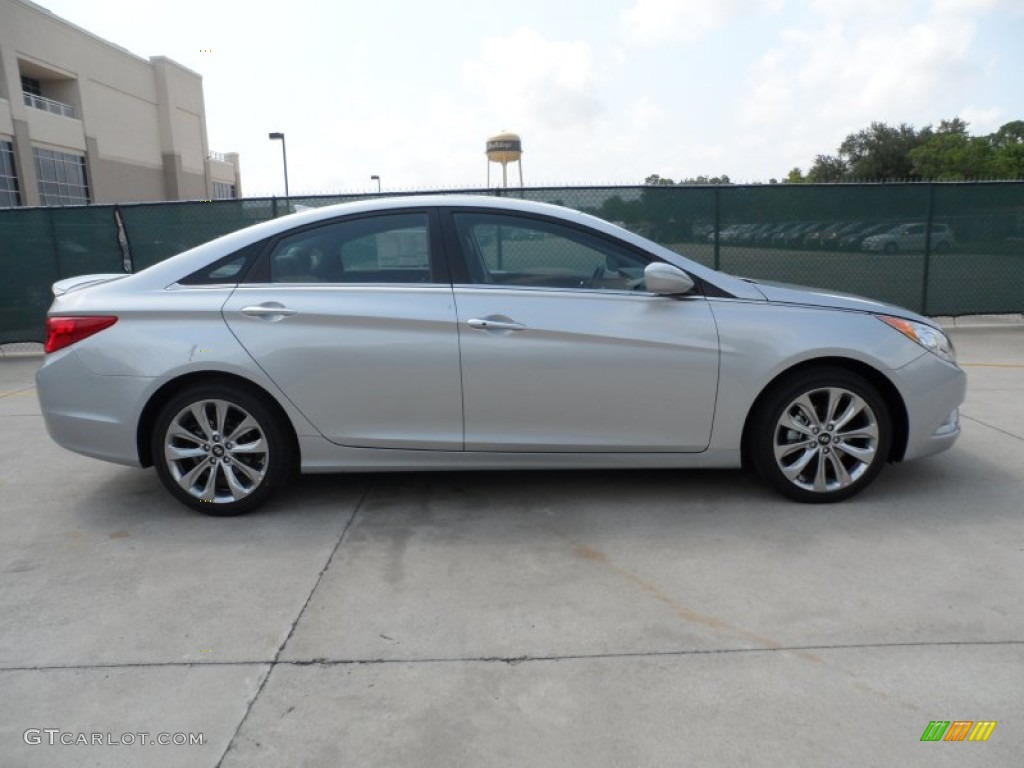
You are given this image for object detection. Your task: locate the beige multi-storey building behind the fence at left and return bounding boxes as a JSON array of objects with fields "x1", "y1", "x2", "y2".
[{"x1": 0, "y1": 0, "x2": 242, "y2": 208}]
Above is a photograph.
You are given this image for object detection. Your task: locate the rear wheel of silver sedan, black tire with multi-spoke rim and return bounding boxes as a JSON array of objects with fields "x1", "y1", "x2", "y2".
[{"x1": 150, "y1": 383, "x2": 294, "y2": 517}]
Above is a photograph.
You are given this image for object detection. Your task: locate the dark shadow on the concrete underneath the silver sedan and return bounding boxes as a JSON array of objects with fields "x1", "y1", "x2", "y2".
[{"x1": 78, "y1": 434, "x2": 1021, "y2": 525}]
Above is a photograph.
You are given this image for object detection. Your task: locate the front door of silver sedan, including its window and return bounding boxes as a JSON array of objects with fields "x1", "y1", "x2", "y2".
[{"x1": 452, "y1": 211, "x2": 719, "y2": 452}]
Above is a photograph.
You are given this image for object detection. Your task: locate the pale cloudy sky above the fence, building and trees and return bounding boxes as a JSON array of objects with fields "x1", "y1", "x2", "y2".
[{"x1": 37, "y1": 0, "x2": 1024, "y2": 196}]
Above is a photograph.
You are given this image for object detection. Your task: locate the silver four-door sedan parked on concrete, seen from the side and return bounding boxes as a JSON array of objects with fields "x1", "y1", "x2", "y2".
[{"x1": 37, "y1": 196, "x2": 966, "y2": 515}]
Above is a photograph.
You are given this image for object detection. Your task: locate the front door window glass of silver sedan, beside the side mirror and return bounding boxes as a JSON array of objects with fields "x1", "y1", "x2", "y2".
[{"x1": 454, "y1": 213, "x2": 651, "y2": 291}]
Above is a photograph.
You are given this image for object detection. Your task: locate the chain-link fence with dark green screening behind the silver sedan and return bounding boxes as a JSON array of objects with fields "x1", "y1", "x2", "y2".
[{"x1": 0, "y1": 181, "x2": 1024, "y2": 343}]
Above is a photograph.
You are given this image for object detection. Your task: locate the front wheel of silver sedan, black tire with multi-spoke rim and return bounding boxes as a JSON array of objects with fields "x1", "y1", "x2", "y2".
[{"x1": 745, "y1": 366, "x2": 893, "y2": 504}]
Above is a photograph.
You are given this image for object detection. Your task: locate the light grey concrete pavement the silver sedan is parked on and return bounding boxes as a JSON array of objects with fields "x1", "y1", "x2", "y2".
[{"x1": 0, "y1": 326, "x2": 1024, "y2": 766}]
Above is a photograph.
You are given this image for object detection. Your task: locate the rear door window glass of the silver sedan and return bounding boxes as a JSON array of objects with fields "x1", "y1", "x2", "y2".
[{"x1": 270, "y1": 213, "x2": 438, "y2": 283}]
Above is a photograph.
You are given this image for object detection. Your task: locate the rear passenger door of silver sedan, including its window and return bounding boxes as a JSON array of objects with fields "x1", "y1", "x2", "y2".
[{"x1": 223, "y1": 209, "x2": 463, "y2": 451}]
